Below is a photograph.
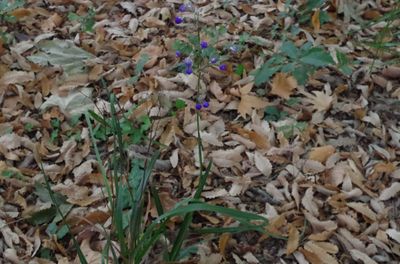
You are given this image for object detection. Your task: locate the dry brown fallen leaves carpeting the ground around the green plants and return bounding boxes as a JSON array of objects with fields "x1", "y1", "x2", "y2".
[{"x1": 0, "y1": 0, "x2": 400, "y2": 263}]
